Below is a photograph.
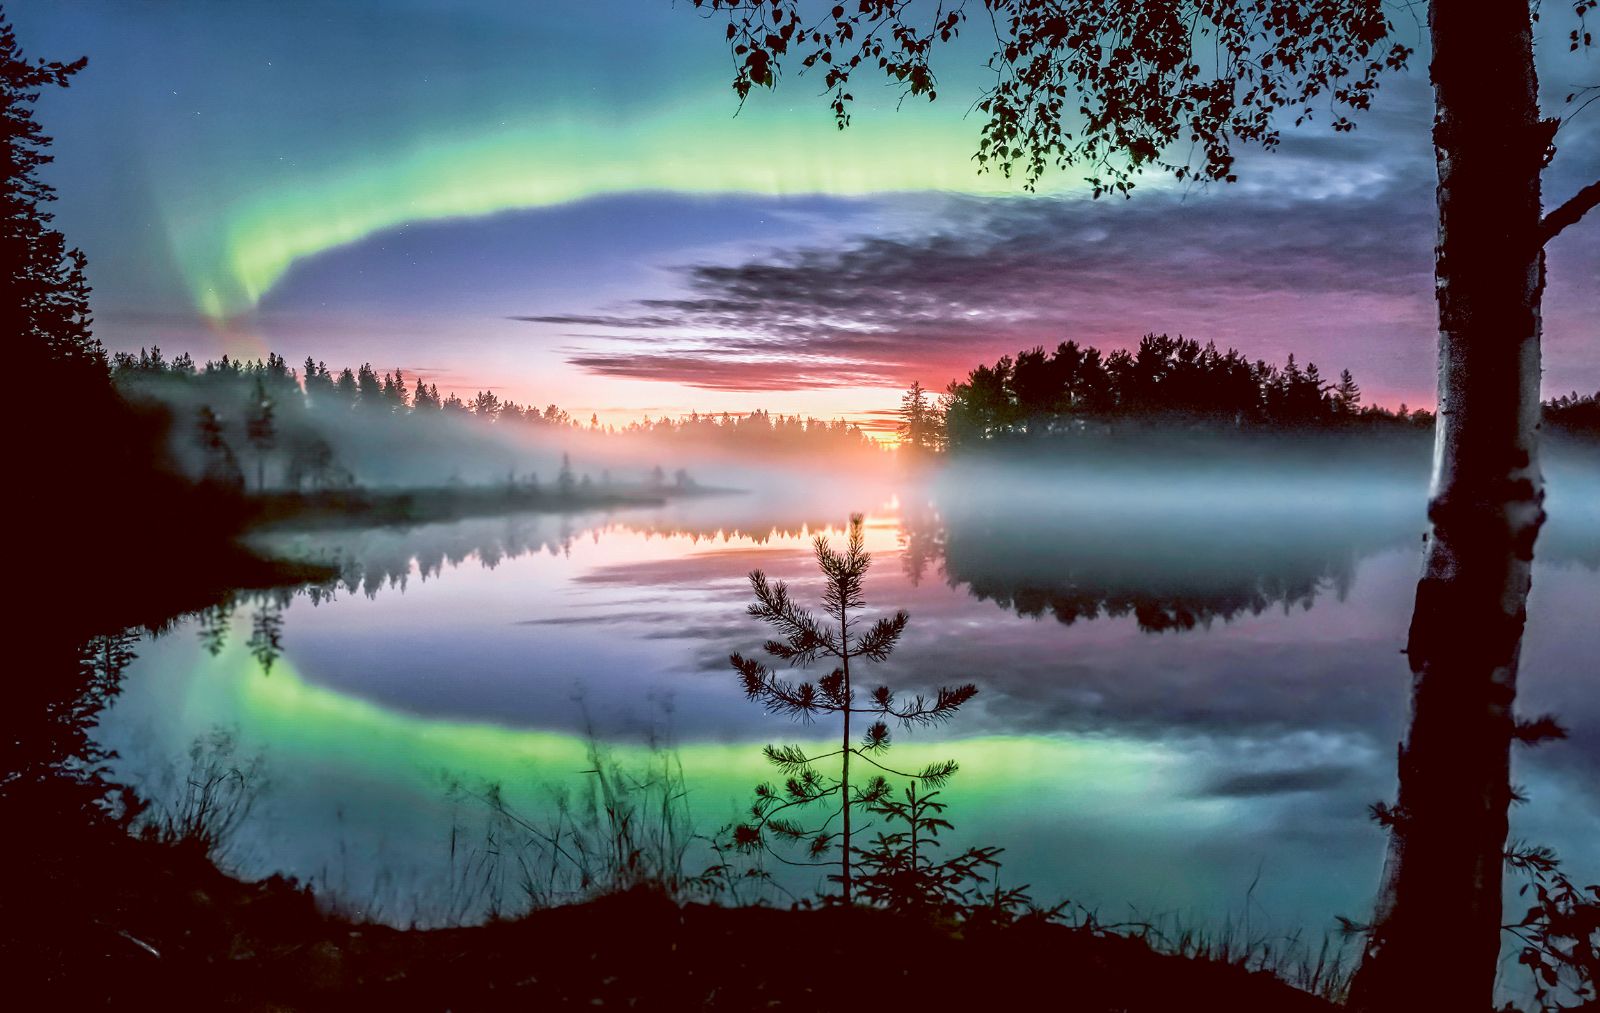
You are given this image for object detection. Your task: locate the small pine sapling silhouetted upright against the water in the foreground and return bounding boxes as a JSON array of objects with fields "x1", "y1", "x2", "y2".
[{"x1": 730, "y1": 514, "x2": 978, "y2": 904}]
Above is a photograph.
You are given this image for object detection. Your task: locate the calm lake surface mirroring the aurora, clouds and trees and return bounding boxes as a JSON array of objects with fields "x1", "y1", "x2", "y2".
[{"x1": 101, "y1": 460, "x2": 1600, "y2": 928}]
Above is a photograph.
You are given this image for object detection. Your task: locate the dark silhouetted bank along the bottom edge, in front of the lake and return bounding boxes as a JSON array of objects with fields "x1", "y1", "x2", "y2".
[{"x1": 5, "y1": 839, "x2": 1333, "y2": 1013}]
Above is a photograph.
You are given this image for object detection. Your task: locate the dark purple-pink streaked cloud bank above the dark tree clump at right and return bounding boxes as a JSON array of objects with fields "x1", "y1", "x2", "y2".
[{"x1": 518, "y1": 146, "x2": 1452, "y2": 390}]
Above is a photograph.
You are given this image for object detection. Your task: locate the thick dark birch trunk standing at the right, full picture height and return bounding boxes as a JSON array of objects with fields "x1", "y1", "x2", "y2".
[{"x1": 1350, "y1": 0, "x2": 1549, "y2": 1011}]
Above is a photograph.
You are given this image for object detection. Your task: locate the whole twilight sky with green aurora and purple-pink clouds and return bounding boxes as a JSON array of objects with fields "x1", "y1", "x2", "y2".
[{"x1": 6, "y1": 0, "x2": 1600, "y2": 421}]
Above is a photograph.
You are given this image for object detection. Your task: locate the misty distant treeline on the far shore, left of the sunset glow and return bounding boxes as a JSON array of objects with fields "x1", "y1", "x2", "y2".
[{"x1": 110, "y1": 347, "x2": 877, "y2": 493}]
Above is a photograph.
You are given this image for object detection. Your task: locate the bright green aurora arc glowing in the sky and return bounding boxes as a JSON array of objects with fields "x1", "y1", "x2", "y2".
[{"x1": 178, "y1": 106, "x2": 1021, "y2": 320}]
